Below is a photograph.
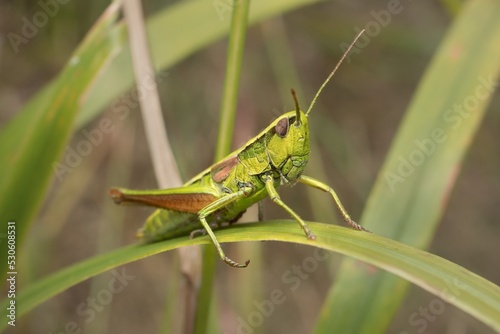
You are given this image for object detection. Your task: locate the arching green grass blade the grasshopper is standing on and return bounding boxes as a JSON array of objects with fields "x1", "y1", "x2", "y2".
[{"x1": 0, "y1": 220, "x2": 500, "y2": 330}]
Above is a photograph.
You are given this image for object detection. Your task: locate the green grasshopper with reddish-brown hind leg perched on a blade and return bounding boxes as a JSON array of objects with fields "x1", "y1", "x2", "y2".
[{"x1": 109, "y1": 31, "x2": 365, "y2": 268}]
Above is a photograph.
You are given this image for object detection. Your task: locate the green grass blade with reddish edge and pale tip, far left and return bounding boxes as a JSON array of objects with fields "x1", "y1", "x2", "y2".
[{"x1": 0, "y1": 6, "x2": 121, "y2": 275}]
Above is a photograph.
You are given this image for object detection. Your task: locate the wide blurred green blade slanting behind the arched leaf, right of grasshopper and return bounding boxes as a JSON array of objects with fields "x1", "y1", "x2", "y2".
[{"x1": 316, "y1": 0, "x2": 500, "y2": 334}]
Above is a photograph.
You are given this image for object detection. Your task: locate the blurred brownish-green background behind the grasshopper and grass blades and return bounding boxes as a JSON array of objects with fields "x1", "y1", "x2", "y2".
[{"x1": 0, "y1": 0, "x2": 500, "y2": 333}]
